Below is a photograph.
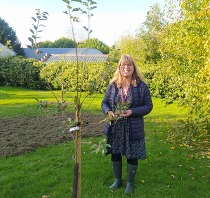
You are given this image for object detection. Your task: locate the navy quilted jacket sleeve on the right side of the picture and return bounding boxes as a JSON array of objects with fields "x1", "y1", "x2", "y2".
[{"x1": 130, "y1": 84, "x2": 153, "y2": 117}]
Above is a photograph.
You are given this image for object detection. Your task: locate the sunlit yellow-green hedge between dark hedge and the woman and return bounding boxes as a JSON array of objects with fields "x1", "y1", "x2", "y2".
[{"x1": 40, "y1": 62, "x2": 116, "y2": 93}]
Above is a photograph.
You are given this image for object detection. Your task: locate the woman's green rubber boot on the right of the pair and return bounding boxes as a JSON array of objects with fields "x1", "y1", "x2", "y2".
[{"x1": 125, "y1": 164, "x2": 138, "y2": 194}]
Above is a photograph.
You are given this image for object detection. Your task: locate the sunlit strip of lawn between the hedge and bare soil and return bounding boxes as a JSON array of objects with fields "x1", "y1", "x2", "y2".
[{"x1": 0, "y1": 87, "x2": 102, "y2": 118}]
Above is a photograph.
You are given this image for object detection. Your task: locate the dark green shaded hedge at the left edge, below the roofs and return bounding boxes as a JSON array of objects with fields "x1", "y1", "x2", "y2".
[{"x1": 0, "y1": 57, "x2": 47, "y2": 89}]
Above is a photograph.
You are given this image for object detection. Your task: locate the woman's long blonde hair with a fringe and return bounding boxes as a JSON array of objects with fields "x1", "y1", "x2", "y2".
[{"x1": 110, "y1": 54, "x2": 146, "y2": 88}]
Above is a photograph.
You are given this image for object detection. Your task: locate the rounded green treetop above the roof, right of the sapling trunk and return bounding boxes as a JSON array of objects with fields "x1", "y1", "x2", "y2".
[{"x1": 78, "y1": 38, "x2": 110, "y2": 54}]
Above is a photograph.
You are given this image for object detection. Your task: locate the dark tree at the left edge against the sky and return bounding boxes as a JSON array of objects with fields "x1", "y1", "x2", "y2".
[{"x1": 0, "y1": 17, "x2": 24, "y2": 56}]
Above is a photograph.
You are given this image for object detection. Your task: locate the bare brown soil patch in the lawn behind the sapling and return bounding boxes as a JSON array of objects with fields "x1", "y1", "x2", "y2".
[{"x1": 0, "y1": 115, "x2": 104, "y2": 156}]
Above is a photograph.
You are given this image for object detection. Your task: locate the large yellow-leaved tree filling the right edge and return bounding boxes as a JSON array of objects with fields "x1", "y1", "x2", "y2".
[{"x1": 151, "y1": 0, "x2": 210, "y2": 151}]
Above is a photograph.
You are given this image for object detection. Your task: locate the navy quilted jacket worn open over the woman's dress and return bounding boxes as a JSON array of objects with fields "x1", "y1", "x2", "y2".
[{"x1": 101, "y1": 80, "x2": 153, "y2": 140}]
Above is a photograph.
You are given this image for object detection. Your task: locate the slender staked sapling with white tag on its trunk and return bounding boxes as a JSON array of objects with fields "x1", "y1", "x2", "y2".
[{"x1": 63, "y1": 0, "x2": 97, "y2": 198}]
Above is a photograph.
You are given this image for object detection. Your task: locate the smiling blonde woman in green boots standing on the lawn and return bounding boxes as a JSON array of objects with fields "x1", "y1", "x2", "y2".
[{"x1": 101, "y1": 55, "x2": 153, "y2": 194}]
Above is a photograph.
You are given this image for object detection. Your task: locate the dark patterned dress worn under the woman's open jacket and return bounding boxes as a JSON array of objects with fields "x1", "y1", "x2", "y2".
[{"x1": 107, "y1": 86, "x2": 146, "y2": 160}]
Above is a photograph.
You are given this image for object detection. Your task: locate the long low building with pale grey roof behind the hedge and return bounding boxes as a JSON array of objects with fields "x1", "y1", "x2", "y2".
[{"x1": 24, "y1": 48, "x2": 108, "y2": 63}]
